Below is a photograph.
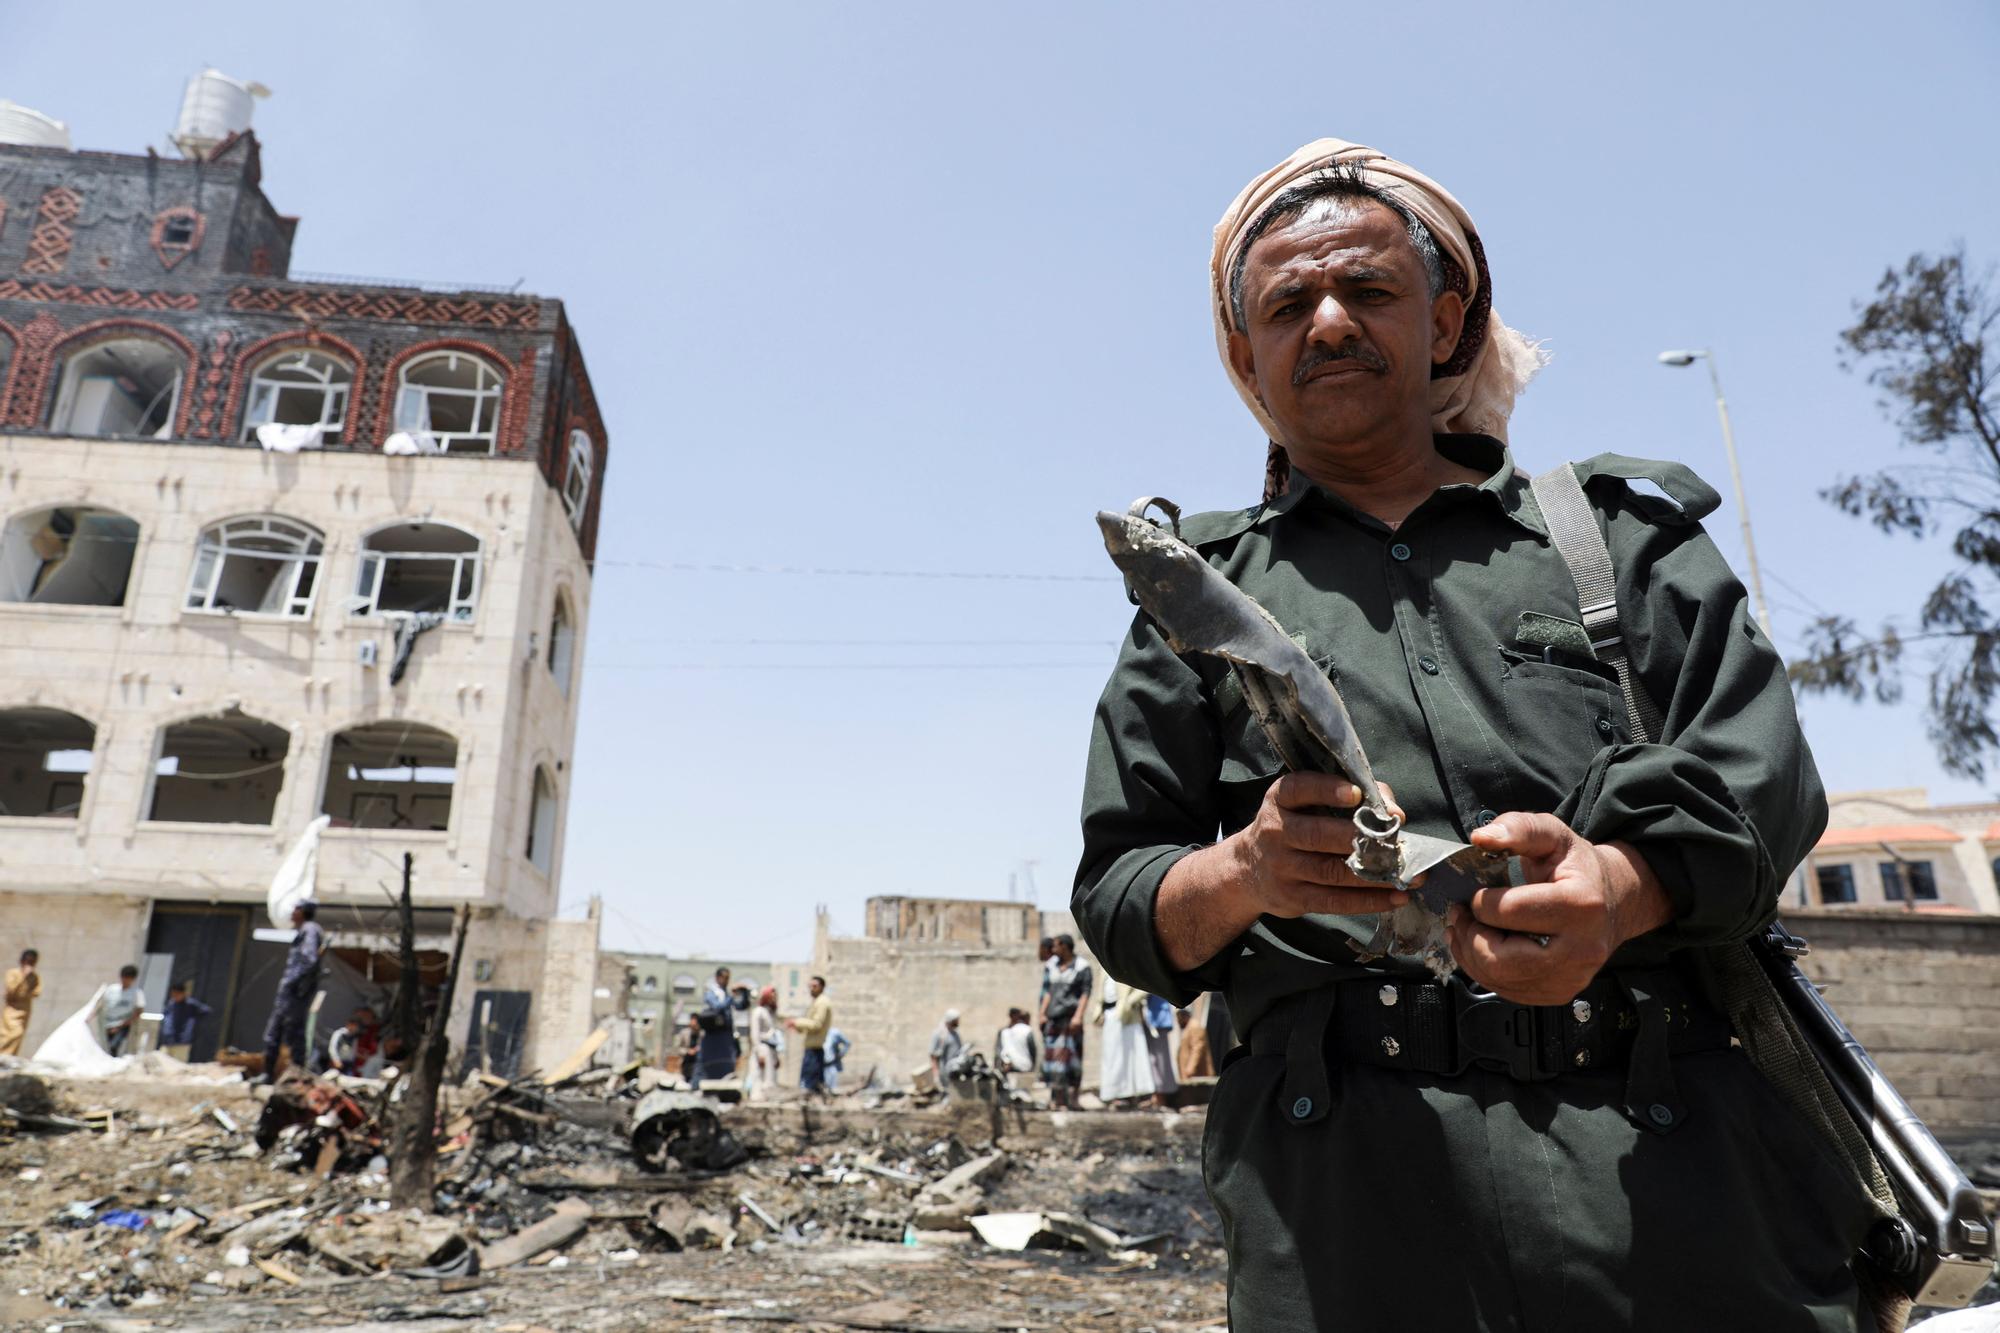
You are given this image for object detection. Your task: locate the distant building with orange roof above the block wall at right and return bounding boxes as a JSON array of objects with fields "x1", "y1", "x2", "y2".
[{"x1": 1790, "y1": 787, "x2": 2000, "y2": 915}]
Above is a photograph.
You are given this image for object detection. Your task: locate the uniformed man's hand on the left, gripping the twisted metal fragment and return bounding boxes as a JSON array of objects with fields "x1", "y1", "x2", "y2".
[{"x1": 1222, "y1": 773, "x2": 1410, "y2": 917}]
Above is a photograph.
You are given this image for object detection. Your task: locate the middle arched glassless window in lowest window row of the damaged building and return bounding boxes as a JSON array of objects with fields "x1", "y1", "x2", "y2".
[{"x1": 146, "y1": 709, "x2": 292, "y2": 825}]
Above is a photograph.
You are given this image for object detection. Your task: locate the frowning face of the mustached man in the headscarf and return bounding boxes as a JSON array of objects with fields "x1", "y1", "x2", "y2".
[{"x1": 1230, "y1": 198, "x2": 1464, "y2": 470}]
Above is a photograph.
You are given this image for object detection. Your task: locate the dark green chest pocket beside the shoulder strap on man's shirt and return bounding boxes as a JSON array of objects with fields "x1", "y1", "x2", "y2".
[{"x1": 1500, "y1": 648, "x2": 1632, "y2": 811}]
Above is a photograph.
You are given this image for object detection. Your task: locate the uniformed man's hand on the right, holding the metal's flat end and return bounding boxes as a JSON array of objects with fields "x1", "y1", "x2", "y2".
[{"x1": 1448, "y1": 811, "x2": 1674, "y2": 1005}]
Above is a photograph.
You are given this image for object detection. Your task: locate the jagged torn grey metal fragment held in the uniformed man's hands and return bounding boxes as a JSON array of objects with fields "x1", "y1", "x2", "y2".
[{"x1": 1098, "y1": 496, "x2": 1508, "y2": 975}]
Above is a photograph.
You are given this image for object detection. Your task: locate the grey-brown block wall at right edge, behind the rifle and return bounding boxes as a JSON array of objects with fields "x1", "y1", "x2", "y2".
[{"x1": 1786, "y1": 909, "x2": 2000, "y2": 1143}]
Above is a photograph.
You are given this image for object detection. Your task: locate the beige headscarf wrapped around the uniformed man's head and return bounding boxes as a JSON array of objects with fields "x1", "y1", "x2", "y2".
[{"x1": 1208, "y1": 138, "x2": 1548, "y2": 498}]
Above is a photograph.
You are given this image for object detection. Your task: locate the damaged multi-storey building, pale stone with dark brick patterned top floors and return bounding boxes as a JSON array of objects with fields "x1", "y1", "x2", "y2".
[{"x1": 0, "y1": 72, "x2": 606, "y2": 1067}]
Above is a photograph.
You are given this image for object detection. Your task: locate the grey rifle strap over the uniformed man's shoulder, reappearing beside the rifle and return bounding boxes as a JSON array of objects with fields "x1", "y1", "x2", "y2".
[{"x1": 1532, "y1": 464, "x2": 1896, "y2": 1215}]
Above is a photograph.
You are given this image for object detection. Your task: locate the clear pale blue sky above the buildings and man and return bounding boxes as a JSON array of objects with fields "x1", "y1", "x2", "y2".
[{"x1": 0, "y1": 0, "x2": 2000, "y2": 957}]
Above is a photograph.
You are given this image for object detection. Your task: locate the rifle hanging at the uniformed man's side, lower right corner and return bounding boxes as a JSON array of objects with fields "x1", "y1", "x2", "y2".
[{"x1": 1750, "y1": 921, "x2": 1994, "y2": 1307}]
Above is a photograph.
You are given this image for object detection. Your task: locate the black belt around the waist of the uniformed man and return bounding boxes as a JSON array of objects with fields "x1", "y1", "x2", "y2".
[{"x1": 1250, "y1": 969, "x2": 1730, "y2": 1083}]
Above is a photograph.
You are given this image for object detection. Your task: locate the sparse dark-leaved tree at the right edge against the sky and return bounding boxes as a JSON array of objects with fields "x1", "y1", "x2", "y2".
[{"x1": 1792, "y1": 244, "x2": 2000, "y2": 779}]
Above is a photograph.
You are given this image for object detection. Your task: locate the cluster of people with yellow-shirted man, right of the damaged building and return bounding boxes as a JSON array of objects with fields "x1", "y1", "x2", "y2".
[{"x1": 680, "y1": 967, "x2": 852, "y2": 1097}]
